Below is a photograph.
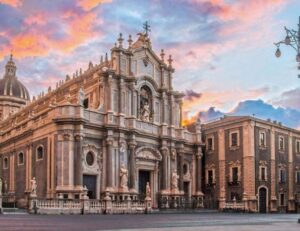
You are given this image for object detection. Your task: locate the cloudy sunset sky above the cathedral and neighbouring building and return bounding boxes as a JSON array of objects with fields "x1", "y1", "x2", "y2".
[{"x1": 0, "y1": 0, "x2": 300, "y2": 128}]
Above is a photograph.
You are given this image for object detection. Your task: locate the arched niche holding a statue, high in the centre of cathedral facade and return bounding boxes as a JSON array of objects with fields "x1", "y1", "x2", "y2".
[{"x1": 139, "y1": 86, "x2": 152, "y2": 122}]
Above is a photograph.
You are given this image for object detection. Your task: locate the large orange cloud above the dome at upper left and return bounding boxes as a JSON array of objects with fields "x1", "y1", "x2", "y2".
[{"x1": 0, "y1": 11, "x2": 101, "y2": 58}]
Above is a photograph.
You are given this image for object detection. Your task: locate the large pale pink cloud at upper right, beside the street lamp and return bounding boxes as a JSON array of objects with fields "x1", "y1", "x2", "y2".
[{"x1": 168, "y1": 0, "x2": 287, "y2": 69}]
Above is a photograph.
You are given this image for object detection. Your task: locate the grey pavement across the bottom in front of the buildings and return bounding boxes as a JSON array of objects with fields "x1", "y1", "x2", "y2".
[{"x1": 0, "y1": 213, "x2": 300, "y2": 231}]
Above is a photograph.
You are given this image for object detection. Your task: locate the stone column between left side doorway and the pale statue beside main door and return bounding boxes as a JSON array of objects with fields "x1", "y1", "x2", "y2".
[{"x1": 106, "y1": 137, "x2": 113, "y2": 191}]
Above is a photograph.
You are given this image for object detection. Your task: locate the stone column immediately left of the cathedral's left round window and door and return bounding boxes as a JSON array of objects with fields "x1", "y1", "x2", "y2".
[{"x1": 74, "y1": 134, "x2": 83, "y2": 187}]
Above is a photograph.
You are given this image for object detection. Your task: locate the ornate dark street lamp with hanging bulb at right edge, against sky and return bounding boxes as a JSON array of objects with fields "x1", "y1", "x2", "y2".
[{"x1": 274, "y1": 17, "x2": 300, "y2": 78}]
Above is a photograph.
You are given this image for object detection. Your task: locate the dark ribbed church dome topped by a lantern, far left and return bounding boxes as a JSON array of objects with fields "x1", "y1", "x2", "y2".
[{"x1": 0, "y1": 55, "x2": 30, "y2": 101}]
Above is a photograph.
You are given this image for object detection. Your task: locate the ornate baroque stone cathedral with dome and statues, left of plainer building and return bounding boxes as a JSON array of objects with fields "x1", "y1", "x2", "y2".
[{"x1": 0, "y1": 29, "x2": 204, "y2": 207}]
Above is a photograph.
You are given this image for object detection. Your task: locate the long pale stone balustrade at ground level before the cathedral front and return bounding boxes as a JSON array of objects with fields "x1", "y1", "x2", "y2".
[{"x1": 29, "y1": 197, "x2": 151, "y2": 214}]
